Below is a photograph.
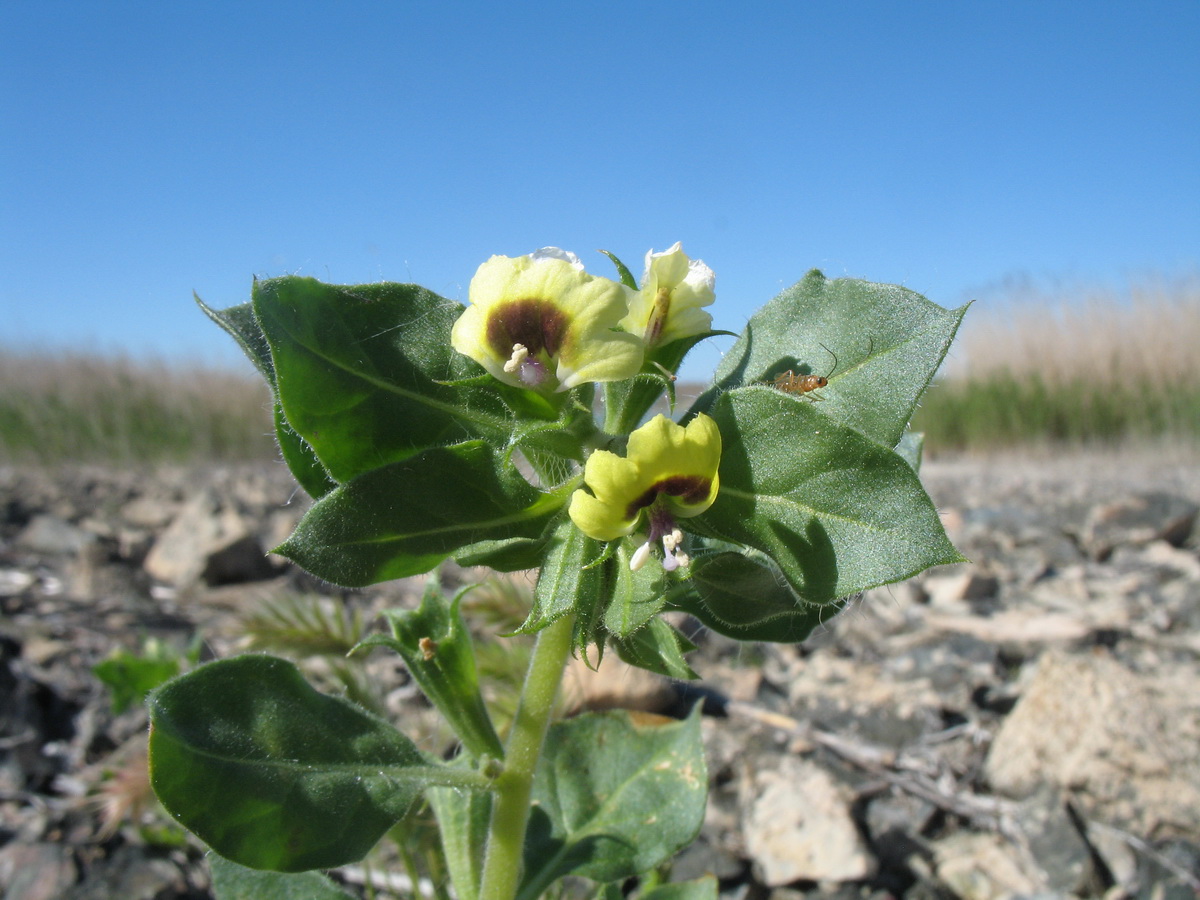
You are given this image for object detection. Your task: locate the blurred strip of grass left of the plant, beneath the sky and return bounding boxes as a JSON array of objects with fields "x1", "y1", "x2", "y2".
[{"x1": 0, "y1": 348, "x2": 277, "y2": 463}]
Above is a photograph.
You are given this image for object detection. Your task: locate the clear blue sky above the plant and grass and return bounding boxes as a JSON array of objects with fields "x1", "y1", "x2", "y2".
[{"x1": 0, "y1": 0, "x2": 1200, "y2": 374}]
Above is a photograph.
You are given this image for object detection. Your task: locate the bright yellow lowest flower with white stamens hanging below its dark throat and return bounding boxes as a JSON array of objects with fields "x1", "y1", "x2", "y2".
[{"x1": 569, "y1": 414, "x2": 721, "y2": 570}]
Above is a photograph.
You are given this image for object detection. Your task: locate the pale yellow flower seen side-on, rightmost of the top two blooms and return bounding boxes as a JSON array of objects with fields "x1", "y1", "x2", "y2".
[{"x1": 620, "y1": 241, "x2": 716, "y2": 347}]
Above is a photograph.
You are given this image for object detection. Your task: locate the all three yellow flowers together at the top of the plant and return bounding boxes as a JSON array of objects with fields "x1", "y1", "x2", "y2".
[{"x1": 450, "y1": 244, "x2": 721, "y2": 571}]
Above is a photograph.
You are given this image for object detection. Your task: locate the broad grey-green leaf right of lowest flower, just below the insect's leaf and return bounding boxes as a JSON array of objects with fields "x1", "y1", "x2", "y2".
[{"x1": 692, "y1": 386, "x2": 964, "y2": 604}]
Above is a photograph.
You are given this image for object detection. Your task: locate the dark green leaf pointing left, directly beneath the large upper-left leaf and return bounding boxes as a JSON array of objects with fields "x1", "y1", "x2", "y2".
[{"x1": 275, "y1": 440, "x2": 568, "y2": 587}]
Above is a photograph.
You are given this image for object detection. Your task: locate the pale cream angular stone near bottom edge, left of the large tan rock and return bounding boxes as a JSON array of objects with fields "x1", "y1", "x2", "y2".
[{"x1": 742, "y1": 756, "x2": 875, "y2": 887}]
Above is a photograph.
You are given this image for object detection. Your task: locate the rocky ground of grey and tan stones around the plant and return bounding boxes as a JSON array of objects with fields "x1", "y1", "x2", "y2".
[{"x1": 0, "y1": 454, "x2": 1200, "y2": 900}]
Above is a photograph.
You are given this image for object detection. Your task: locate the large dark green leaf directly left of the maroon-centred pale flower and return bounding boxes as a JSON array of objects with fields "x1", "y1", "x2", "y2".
[{"x1": 253, "y1": 276, "x2": 520, "y2": 482}]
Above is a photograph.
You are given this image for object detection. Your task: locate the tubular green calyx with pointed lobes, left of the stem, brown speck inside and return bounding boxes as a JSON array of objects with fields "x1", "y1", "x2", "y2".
[{"x1": 354, "y1": 578, "x2": 504, "y2": 760}]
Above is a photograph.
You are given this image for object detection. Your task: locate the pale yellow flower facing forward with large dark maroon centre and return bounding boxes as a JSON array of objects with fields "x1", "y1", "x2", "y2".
[{"x1": 450, "y1": 247, "x2": 643, "y2": 390}]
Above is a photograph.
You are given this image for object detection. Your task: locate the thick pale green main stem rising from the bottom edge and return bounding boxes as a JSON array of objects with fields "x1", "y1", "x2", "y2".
[{"x1": 479, "y1": 616, "x2": 575, "y2": 900}]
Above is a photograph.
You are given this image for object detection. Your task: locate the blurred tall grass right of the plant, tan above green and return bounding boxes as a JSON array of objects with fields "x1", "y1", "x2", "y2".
[{"x1": 913, "y1": 277, "x2": 1200, "y2": 451}]
